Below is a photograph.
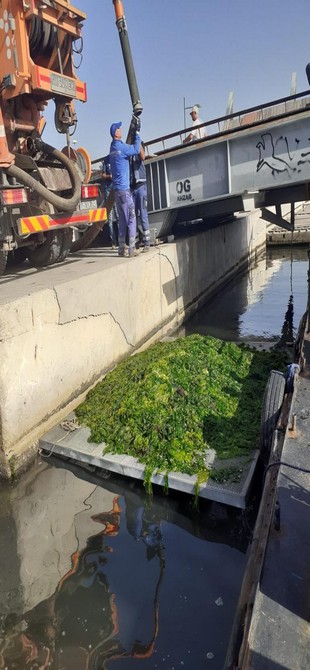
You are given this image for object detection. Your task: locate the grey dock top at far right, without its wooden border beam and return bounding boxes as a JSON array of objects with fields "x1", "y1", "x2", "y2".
[{"x1": 242, "y1": 333, "x2": 310, "y2": 670}]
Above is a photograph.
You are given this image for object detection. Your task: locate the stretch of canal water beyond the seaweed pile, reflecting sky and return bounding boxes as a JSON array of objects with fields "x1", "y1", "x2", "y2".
[{"x1": 185, "y1": 248, "x2": 308, "y2": 342}]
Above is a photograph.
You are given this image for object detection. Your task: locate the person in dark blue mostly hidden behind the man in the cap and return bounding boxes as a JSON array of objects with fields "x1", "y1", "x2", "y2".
[{"x1": 130, "y1": 142, "x2": 150, "y2": 252}]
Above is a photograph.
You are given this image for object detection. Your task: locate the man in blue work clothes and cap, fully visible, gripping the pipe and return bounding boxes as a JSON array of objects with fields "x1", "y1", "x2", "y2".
[{"x1": 110, "y1": 116, "x2": 141, "y2": 258}]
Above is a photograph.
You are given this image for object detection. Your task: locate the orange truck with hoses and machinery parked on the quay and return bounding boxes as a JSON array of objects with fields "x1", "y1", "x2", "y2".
[{"x1": 0, "y1": 0, "x2": 107, "y2": 275}]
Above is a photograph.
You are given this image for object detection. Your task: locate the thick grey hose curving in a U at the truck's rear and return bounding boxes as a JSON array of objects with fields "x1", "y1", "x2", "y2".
[{"x1": 5, "y1": 143, "x2": 81, "y2": 212}]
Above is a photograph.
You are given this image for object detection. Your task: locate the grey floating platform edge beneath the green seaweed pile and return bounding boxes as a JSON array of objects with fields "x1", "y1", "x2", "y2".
[{"x1": 39, "y1": 413, "x2": 259, "y2": 509}]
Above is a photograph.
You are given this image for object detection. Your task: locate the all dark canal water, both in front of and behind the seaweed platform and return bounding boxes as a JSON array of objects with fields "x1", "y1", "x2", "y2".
[{"x1": 0, "y1": 250, "x2": 308, "y2": 670}]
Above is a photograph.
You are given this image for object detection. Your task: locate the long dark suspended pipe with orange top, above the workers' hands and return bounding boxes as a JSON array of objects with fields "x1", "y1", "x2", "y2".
[{"x1": 112, "y1": 0, "x2": 143, "y2": 116}]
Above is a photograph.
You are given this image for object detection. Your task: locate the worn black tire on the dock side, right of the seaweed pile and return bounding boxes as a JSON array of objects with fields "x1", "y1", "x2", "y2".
[{"x1": 260, "y1": 370, "x2": 286, "y2": 465}]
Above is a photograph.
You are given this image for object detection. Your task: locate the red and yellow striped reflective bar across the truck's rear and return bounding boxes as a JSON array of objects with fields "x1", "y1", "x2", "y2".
[{"x1": 17, "y1": 207, "x2": 107, "y2": 235}]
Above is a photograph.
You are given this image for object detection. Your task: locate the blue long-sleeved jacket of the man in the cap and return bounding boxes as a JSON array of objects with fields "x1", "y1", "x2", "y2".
[{"x1": 110, "y1": 133, "x2": 141, "y2": 191}]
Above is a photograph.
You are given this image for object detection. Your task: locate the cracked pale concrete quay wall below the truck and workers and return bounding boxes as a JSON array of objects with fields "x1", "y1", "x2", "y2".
[{"x1": 0, "y1": 211, "x2": 266, "y2": 477}]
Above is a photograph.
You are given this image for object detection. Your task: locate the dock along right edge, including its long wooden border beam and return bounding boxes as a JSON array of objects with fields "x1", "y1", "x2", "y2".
[{"x1": 224, "y1": 323, "x2": 310, "y2": 670}]
